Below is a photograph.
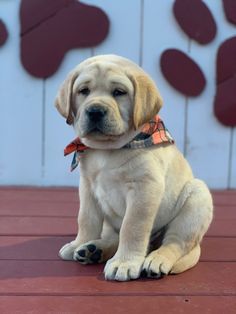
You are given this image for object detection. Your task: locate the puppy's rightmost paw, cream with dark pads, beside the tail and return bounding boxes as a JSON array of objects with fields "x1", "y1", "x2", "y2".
[{"x1": 142, "y1": 251, "x2": 173, "y2": 279}]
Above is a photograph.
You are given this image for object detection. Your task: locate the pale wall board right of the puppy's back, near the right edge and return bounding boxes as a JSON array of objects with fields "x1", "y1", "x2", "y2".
[{"x1": 187, "y1": 0, "x2": 235, "y2": 188}]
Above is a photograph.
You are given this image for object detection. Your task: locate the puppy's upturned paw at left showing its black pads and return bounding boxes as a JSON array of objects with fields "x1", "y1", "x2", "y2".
[{"x1": 73, "y1": 244, "x2": 103, "y2": 264}]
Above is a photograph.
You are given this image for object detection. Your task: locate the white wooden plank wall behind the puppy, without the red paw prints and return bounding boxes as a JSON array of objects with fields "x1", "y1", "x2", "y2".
[{"x1": 0, "y1": 0, "x2": 236, "y2": 188}]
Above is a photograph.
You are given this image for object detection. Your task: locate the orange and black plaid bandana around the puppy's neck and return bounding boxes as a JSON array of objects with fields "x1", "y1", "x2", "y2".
[{"x1": 64, "y1": 115, "x2": 174, "y2": 171}]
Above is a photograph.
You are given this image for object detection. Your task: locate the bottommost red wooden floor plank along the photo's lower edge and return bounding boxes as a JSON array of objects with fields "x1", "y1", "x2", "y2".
[{"x1": 0, "y1": 296, "x2": 236, "y2": 314}]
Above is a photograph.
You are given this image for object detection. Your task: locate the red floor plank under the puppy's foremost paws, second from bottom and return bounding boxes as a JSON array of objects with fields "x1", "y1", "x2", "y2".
[{"x1": 0, "y1": 261, "x2": 236, "y2": 296}]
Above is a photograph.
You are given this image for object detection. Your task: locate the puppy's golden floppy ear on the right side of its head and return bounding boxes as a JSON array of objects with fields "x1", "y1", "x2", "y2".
[{"x1": 131, "y1": 73, "x2": 162, "y2": 130}]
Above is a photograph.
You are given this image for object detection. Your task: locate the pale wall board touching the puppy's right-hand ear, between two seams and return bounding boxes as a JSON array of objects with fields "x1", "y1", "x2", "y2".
[{"x1": 141, "y1": 0, "x2": 188, "y2": 151}]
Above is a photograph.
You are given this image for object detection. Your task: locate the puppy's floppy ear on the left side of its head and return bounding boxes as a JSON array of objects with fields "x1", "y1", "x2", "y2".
[{"x1": 55, "y1": 71, "x2": 79, "y2": 124}]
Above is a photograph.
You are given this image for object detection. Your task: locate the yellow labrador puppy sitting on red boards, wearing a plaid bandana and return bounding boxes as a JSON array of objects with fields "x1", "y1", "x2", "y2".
[{"x1": 56, "y1": 55, "x2": 213, "y2": 281}]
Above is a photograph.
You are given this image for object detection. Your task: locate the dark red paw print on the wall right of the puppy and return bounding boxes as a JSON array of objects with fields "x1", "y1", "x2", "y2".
[{"x1": 160, "y1": 0, "x2": 236, "y2": 127}]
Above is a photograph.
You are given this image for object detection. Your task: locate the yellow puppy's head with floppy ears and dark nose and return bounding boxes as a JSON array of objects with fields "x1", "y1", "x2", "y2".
[{"x1": 56, "y1": 55, "x2": 162, "y2": 148}]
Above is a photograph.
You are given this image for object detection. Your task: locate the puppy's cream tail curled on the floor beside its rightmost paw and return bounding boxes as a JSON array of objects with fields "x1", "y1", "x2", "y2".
[{"x1": 171, "y1": 244, "x2": 201, "y2": 274}]
